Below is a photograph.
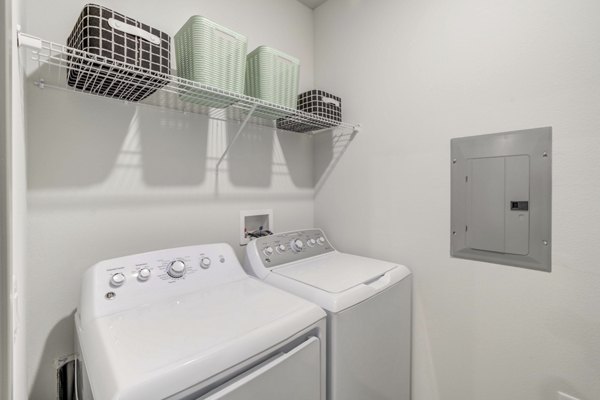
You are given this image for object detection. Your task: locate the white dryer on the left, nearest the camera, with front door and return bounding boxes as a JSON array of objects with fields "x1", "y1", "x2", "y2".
[{"x1": 75, "y1": 244, "x2": 326, "y2": 400}]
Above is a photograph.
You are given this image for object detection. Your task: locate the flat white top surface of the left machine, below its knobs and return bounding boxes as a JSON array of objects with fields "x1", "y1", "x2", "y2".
[{"x1": 76, "y1": 277, "x2": 325, "y2": 400}]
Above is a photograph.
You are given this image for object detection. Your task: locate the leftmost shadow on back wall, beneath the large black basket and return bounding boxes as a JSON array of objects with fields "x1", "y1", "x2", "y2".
[{"x1": 27, "y1": 86, "x2": 135, "y2": 189}]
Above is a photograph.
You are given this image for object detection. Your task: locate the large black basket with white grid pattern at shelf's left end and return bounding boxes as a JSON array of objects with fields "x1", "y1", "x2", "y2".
[{"x1": 67, "y1": 4, "x2": 171, "y2": 101}]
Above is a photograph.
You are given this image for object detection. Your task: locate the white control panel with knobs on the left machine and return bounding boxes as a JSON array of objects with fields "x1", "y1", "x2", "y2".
[{"x1": 78, "y1": 243, "x2": 248, "y2": 320}]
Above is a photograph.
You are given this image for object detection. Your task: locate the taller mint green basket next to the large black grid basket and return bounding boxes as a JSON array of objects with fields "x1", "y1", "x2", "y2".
[{"x1": 175, "y1": 15, "x2": 247, "y2": 108}]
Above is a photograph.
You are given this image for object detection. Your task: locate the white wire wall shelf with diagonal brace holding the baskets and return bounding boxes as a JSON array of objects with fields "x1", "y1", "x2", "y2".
[{"x1": 18, "y1": 32, "x2": 360, "y2": 171}]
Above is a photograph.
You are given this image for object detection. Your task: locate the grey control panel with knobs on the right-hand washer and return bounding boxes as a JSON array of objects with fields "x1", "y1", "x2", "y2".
[{"x1": 255, "y1": 229, "x2": 335, "y2": 268}]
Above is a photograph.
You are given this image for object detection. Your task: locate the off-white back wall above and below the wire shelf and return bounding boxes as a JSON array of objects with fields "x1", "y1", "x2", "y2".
[{"x1": 25, "y1": 0, "x2": 314, "y2": 399}]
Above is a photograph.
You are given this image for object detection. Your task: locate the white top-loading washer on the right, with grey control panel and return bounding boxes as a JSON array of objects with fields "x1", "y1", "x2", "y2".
[{"x1": 244, "y1": 229, "x2": 412, "y2": 400}]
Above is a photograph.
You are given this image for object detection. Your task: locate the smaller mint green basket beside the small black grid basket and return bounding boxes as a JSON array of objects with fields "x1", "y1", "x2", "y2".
[{"x1": 246, "y1": 46, "x2": 300, "y2": 119}]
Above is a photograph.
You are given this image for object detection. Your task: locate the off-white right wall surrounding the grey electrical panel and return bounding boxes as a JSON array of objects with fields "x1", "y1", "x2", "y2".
[{"x1": 315, "y1": 0, "x2": 600, "y2": 400}]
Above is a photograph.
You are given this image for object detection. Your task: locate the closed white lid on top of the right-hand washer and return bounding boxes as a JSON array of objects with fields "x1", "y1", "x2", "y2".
[{"x1": 272, "y1": 252, "x2": 397, "y2": 293}]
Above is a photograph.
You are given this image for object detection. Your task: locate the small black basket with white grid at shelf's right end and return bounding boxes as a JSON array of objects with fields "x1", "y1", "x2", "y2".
[{"x1": 277, "y1": 90, "x2": 342, "y2": 132}]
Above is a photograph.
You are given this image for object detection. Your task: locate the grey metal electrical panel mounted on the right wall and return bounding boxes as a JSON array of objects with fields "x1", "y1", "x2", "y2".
[{"x1": 450, "y1": 128, "x2": 552, "y2": 271}]
